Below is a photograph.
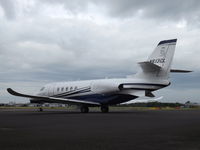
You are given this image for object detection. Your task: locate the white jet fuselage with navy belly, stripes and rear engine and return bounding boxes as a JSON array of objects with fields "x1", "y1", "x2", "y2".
[{"x1": 35, "y1": 78, "x2": 169, "y2": 105}]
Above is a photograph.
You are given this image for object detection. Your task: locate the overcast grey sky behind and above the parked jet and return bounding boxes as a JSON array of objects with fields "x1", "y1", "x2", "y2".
[{"x1": 0, "y1": 0, "x2": 200, "y2": 102}]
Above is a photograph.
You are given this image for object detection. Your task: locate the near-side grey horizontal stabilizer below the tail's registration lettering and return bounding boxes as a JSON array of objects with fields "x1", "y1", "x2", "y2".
[{"x1": 138, "y1": 61, "x2": 161, "y2": 72}]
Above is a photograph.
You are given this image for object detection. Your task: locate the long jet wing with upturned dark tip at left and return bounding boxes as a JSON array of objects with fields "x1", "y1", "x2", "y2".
[{"x1": 7, "y1": 88, "x2": 101, "y2": 106}]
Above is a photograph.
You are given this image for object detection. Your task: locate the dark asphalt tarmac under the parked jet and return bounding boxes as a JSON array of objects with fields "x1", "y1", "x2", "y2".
[{"x1": 0, "y1": 110, "x2": 200, "y2": 150}]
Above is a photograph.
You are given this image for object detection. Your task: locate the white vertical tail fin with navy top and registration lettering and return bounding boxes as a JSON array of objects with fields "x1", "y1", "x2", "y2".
[{"x1": 136, "y1": 39, "x2": 177, "y2": 79}]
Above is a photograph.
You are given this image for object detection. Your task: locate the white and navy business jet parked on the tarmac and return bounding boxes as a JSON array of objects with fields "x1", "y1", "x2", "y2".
[{"x1": 7, "y1": 39, "x2": 190, "y2": 113}]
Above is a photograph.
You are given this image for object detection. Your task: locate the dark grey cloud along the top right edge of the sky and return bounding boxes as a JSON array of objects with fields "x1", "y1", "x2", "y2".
[{"x1": 99, "y1": 0, "x2": 200, "y2": 19}]
